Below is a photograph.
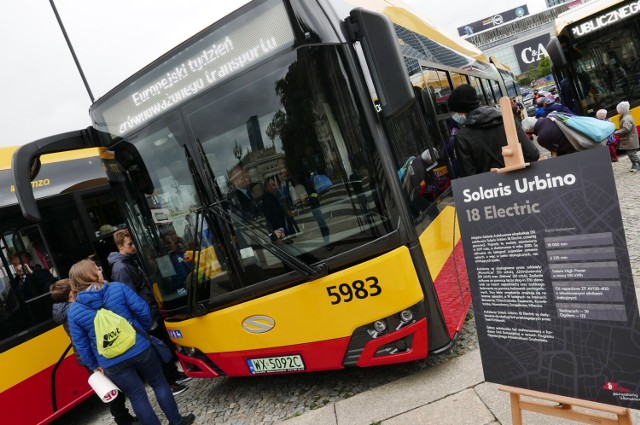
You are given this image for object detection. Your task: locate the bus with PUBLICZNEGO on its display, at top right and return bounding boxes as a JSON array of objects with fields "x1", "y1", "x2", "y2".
[{"x1": 547, "y1": 0, "x2": 640, "y2": 122}]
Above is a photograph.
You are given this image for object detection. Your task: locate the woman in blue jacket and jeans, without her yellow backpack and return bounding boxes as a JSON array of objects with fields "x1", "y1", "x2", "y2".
[{"x1": 68, "y1": 260, "x2": 195, "y2": 425}]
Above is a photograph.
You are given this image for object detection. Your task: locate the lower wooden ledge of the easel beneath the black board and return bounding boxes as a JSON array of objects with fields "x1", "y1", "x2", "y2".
[{"x1": 498, "y1": 385, "x2": 632, "y2": 425}]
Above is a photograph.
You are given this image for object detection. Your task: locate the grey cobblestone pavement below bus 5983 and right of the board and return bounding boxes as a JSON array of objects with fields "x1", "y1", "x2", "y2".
[{"x1": 55, "y1": 157, "x2": 640, "y2": 425}]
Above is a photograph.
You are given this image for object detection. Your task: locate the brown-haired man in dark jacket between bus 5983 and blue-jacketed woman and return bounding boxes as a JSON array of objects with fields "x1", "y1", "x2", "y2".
[{"x1": 107, "y1": 229, "x2": 191, "y2": 395}]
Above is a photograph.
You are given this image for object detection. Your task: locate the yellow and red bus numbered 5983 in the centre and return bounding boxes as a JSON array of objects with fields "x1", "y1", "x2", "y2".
[{"x1": 13, "y1": 0, "x2": 513, "y2": 377}]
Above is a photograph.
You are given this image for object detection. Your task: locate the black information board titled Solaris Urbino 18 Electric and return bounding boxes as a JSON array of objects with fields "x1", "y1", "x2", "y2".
[{"x1": 453, "y1": 148, "x2": 640, "y2": 408}]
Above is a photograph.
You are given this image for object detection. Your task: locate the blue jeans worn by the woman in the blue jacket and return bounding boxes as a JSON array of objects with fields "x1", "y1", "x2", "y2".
[{"x1": 105, "y1": 347, "x2": 182, "y2": 425}]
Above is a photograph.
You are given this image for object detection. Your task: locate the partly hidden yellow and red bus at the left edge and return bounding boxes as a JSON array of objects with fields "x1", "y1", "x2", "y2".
[{"x1": 0, "y1": 147, "x2": 123, "y2": 424}]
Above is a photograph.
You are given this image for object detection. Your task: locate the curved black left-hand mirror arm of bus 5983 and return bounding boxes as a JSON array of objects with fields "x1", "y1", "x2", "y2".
[{"x1": 11, "y1": 128, "x2": 96, "y2": 222}]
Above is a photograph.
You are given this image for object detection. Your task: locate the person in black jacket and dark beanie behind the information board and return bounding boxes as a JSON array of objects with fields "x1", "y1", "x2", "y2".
[{"x1": 447, "y1": 84, "x2": 540, "y2": 176}]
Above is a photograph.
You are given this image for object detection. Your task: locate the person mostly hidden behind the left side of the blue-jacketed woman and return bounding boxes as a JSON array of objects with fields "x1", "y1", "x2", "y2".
[{"x1": 49, "y1": 279, "x2": 138, "y2": 425}]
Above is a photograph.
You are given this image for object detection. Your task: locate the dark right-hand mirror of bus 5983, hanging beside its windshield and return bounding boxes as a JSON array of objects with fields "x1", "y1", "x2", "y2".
[{"x1": 345, "y1": 8, "x2": 414, "y2": 118}]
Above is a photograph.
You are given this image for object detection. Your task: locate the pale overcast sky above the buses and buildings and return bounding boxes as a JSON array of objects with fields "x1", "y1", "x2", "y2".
[{"x1": 0, "y1": 0, "x2": 545, "y2": 147}]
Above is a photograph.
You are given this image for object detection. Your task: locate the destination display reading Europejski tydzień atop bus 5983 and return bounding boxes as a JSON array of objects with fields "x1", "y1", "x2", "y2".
[{"x1": 91, "y1": 1, "x2": 294, "y2": 136}]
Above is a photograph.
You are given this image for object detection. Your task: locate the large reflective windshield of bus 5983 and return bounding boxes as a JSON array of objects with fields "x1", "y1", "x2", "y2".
[{"x1": 99, "y1": 46, "x2": 389, "y2": 311}]
